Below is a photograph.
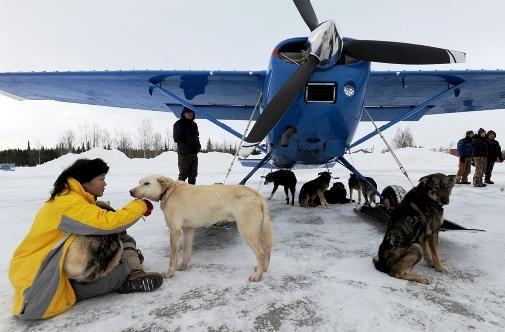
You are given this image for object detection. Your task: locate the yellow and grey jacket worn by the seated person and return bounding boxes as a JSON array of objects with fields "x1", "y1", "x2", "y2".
[{"x1": 9, "y1": 178, "x2": 147, "y2": 319}]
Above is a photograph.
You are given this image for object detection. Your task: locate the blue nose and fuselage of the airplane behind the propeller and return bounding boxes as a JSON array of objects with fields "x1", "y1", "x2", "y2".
[{"x1": 263, "y1": 38, "x2": 370, "y2": 167}]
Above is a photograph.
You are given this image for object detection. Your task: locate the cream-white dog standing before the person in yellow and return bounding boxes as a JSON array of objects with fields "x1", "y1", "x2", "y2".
[{"x1": 130, "y1": 175, "x2": 272, "y2": 281}]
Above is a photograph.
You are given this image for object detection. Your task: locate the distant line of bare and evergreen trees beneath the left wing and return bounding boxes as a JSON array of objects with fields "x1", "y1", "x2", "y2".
[{"x1": 0, "y1": 120, "x2": 237, "y2": 166}]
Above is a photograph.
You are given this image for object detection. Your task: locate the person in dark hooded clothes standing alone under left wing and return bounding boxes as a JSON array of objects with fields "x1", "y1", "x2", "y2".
[{"x1": 174, "y1": 107, "x2": 201, "y2": 184}]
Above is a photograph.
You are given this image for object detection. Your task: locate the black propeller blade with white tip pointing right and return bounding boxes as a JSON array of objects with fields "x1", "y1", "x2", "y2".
[{"x1": 343, "y1": 40, "x2": 465, "y2": 65}]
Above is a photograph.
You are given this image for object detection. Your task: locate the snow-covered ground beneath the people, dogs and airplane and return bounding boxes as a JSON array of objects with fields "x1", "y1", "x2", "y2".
[{"x1": 0, "y1": 149, "x2": 505, "y2": 332}]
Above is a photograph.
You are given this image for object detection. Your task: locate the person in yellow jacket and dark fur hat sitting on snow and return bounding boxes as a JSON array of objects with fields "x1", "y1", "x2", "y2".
[{"x1": 9, "y1": 158, "x2": 163, "y2": 319}]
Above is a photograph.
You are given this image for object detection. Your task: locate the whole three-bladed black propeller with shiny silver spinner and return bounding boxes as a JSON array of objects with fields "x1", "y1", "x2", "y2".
[{"x1": 243, "y1": 0, "x2": 465, "y2": 148}]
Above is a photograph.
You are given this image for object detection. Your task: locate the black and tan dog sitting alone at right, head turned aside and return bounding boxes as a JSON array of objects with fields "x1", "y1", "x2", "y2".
[{"x1": 373, "y1": 173, "x2": 456, "y2": 284}]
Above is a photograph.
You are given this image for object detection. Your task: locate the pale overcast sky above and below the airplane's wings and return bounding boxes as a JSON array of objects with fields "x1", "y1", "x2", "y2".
[{"x1": 0, "y1": 0, "x2": 505, "y2": 149}]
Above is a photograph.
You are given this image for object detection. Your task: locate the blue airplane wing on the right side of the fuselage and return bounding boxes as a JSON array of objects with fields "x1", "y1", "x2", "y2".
[{"x1": 361, "y1": 70, "x2": 505, "y2": 121}]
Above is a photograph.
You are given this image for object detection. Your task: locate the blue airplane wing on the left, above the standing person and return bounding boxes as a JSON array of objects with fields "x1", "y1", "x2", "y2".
[{"x1": 0, "y1": 71, "x2": 266, "y2": 120}]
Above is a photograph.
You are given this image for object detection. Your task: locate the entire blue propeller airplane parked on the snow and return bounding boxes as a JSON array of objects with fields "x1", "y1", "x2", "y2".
[{"x1": 0, "y1": 0, "x2": 505, "y2": 187}]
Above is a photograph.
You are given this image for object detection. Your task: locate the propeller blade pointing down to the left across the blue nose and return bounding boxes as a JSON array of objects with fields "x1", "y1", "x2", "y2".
[{"x1": 244, "y1": 55, "x2": 319, "y2": 147}]
